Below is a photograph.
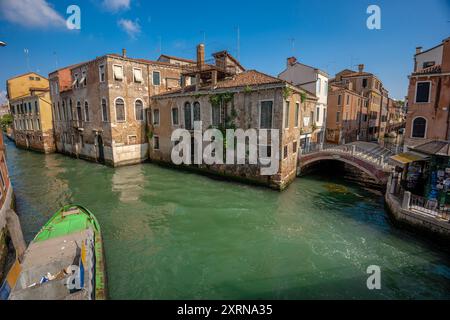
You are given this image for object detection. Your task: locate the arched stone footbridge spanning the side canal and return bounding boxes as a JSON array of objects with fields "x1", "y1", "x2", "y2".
[{"x1": 297, "y1": 142, "x2": 393, "y2": 186}]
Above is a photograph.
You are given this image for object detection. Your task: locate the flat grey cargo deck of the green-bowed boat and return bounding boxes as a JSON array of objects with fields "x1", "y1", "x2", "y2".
[{"x1": 9, "y1": 229, "x2": 95, "y2": 300}]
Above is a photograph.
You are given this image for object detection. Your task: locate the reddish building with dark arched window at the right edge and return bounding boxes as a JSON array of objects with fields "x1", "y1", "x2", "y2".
[{"x1": 405, "y1": 38, "x2": 450, "y2": 147}]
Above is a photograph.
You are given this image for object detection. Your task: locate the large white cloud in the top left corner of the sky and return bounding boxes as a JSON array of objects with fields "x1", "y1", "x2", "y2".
[{"x1": 0, "y1": 0, "x2": 66, "y2": 27}]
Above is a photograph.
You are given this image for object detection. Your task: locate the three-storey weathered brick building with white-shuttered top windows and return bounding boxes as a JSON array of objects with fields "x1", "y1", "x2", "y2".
[{"x1": 50, "y1": 50, "x2": 189, "y2": 166}]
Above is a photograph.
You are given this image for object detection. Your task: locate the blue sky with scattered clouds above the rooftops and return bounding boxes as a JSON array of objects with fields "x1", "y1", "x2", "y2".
[{"x1": 0, "y1": 0, "x2": 450, "y2": 102}]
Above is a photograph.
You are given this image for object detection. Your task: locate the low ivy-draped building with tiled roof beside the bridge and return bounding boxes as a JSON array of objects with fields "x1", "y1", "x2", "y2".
[{"x1": 149, "y1": 45, "x2": 317, "y2": 189}]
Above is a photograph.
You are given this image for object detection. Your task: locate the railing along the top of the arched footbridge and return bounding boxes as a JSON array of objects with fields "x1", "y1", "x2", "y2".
[{"x1": 300, "y1": 144, "x2": 392, "y2": 170}]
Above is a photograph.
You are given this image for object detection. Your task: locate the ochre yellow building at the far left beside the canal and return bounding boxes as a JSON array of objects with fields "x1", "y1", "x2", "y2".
[{"x1": 6, "y1": 72, "x2": 55, "y2": 153}]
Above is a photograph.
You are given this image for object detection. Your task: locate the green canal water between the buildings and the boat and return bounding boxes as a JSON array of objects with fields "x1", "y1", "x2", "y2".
[{"x1": 7, "y1": 138, "x2": 450, "y2": 299}]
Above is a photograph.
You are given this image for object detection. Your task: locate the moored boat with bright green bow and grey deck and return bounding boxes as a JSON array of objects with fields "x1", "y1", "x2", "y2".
[{"x1": 0, "y1": 205, "x2": 107, "y2": 300}]
